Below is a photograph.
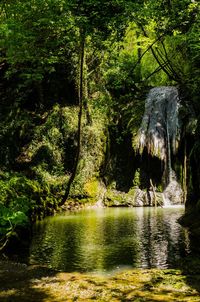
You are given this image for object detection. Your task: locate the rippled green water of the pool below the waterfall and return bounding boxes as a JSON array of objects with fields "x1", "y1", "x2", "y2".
[{"x1": 29, "y1": 207, "x2": 189, "y2": 273}]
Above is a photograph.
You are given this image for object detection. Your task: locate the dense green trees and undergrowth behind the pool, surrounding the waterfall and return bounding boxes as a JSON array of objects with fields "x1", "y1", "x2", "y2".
[{"x1": 0, "y1": 0, "x2": 200, "y2": 249}]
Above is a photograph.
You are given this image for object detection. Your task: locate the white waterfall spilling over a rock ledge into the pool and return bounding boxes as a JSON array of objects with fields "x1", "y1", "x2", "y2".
[{"x1": 137, "y1": 86, "x2": 183, "y2": 205}]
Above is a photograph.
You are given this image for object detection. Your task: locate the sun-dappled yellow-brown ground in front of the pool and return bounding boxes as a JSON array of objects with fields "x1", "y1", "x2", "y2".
[{"x1": 0, "y1": 261, "x2": 200, "y2": 302}]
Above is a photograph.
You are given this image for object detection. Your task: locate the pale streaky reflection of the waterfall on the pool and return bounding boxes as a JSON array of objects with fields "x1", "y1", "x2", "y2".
[{"x1": 138, "y1": 208, "x2": 185, "y2": 268}]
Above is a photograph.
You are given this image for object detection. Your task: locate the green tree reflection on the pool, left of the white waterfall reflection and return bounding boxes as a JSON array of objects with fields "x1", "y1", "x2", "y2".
[{"x1": 31, "y1": 209, "x2": 141, "y2": 271}]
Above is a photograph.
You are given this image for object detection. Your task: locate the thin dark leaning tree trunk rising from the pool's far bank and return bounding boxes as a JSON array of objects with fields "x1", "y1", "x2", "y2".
[{"x1": 60, "y1": 32, "x2": 85, "y2": 206}]
